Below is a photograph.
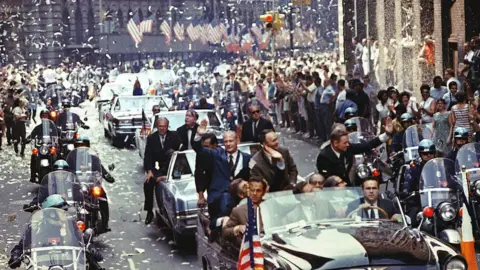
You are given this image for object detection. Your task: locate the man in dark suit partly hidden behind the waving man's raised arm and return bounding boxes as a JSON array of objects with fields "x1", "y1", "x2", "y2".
[{"x1": 195, "y1": 133, "x2": 218, "y2": 206}]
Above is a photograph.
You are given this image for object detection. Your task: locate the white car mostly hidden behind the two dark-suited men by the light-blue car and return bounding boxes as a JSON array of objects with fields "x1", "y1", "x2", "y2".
[{"x1": 135, "y1": 110, "x2": 225, "y2": 158}]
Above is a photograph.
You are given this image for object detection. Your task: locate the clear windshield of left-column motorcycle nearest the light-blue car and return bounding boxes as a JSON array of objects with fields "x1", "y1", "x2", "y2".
[{"x1": 67, "y1": 147, "x2": 102, "y2": 183}]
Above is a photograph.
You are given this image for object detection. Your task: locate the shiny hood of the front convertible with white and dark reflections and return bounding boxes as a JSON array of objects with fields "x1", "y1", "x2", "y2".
[{"x1": 266, "y1": 222, "x2": 435, "y2": 269}]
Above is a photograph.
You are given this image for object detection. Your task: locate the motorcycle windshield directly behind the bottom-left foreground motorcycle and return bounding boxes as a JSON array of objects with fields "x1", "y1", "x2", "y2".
[{"x1": 38, "y1": 171, "x2": 83, "y2": 205}]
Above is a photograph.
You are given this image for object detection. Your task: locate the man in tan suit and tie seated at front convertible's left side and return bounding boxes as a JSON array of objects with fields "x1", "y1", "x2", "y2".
[{"x1": 222, "y1": 178, "x2": 268, "y2": 246}]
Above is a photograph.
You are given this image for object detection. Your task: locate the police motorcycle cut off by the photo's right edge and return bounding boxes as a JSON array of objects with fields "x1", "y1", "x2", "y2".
[{"x1": 455, "y1": 143, "x2": 480, "y2": 239}]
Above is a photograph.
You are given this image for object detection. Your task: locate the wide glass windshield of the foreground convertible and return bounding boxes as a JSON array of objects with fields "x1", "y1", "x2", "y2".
[{"x1": 260, "y1": 188, "x2": 362, "y2": 235}]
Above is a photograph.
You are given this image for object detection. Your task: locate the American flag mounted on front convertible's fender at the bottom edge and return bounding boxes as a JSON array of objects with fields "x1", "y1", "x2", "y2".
[{"x1": 237, "y1": 197, "x2": 264, "y2": 270}]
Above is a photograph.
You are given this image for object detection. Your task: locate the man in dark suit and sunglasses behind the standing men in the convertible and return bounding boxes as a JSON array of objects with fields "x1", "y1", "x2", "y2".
[{"x1": 241, "y1": 105, "x2": 273, "y2": 142}]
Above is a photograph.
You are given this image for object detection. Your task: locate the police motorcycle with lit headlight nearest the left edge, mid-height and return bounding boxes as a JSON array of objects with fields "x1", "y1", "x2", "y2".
[{"x1": 30, "y1": 119, "x2": 59, "y2": 183}]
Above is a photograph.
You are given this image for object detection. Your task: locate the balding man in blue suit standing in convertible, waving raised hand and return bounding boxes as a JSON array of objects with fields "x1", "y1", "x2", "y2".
[{"x1": 192, "y1": 120, "x2": 251, "y2": 224}]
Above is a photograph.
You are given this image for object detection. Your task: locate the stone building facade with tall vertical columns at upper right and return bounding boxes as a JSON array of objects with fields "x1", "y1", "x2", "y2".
[{"x1": 338, "y1": 0, "x2": 480, "y2": 93}]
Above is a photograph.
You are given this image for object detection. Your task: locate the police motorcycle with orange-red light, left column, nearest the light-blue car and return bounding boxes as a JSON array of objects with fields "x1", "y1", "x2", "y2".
[{"x1": 66, "y1": 147, "x2": 108, "y2": 235}]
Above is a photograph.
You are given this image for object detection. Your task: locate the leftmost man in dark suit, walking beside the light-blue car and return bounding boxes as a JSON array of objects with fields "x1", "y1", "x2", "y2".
[{"x1": 143, "y1": 117, "x2": 181, "y2": 224}]
